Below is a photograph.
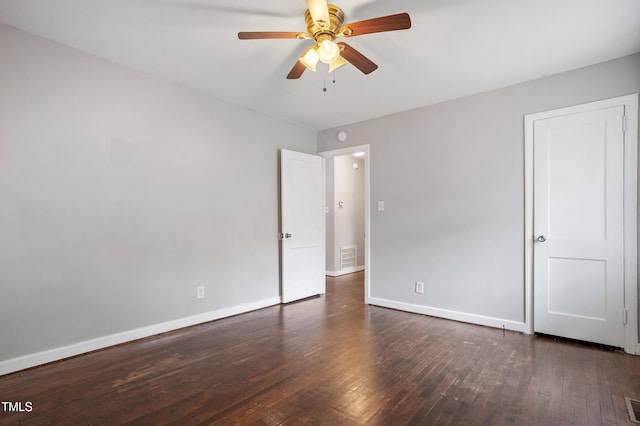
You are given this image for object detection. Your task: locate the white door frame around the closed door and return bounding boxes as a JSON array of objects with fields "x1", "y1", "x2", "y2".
[{"x1": 524, "y1": 93, "x2": 640, "y2": 354}]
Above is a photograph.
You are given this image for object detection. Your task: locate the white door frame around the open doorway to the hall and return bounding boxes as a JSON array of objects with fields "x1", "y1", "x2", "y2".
[{"x1": 318, "y1": 144, "x2": 371, "y2": 304}]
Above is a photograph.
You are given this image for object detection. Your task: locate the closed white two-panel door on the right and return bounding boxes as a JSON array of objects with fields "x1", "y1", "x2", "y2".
[{"x1": 533, "y1": 106, "x2": 625, "y2": 347}]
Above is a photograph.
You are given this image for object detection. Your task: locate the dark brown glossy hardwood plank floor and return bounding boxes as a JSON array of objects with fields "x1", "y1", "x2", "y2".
[{"x1": 0, "y1": 273, "x2": 640, "y2": 425}]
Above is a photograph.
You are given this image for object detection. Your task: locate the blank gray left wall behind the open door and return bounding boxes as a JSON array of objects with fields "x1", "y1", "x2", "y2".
[{"x1": 0, "y1": 25, "x2": 316, "y2": 361}]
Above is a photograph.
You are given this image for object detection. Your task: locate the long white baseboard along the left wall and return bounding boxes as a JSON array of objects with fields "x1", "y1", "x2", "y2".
[{"x1": 0, "y1": 297, "x2": 280, "y2": 376}]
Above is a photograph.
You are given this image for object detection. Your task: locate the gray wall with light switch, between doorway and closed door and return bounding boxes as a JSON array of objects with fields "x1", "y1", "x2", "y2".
[{"x1": 318, "y1": 54, "x2": 640, "y2": 322}]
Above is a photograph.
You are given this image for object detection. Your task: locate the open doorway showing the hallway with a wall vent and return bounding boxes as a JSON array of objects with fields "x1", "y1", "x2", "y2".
[{"x1": 319, "y1": 145, "x2": 370, "y2": 303}]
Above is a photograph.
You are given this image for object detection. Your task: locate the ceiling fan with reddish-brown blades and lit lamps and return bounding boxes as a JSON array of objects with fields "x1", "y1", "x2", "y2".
[{"x1": 238, "y1": 0, "x2": 411, "y2": 79}]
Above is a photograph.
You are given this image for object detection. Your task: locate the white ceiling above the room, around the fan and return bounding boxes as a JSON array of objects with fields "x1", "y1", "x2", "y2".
[{"x1": 0, "y1": 0, "x2": 640, "y2": 130}]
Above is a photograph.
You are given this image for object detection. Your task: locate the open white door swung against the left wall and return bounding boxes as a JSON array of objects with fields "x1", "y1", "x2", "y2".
[{"x1": 280, "y1": 149, "x2": 325, "y2": 303}]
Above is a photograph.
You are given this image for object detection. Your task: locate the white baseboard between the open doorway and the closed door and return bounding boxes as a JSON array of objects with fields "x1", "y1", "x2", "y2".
[{"x1": 367, "y1": 297, "x2": 525, "y2": 333}]
